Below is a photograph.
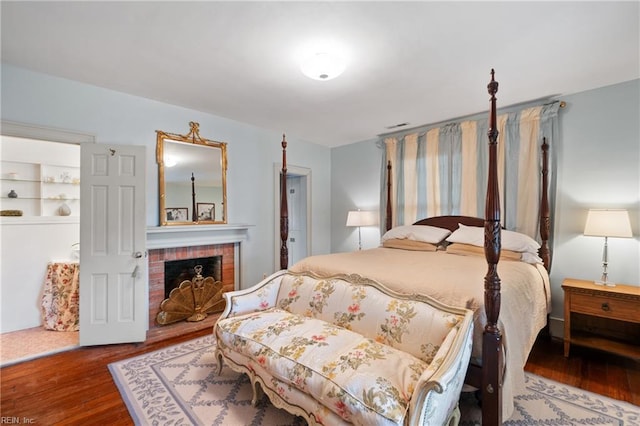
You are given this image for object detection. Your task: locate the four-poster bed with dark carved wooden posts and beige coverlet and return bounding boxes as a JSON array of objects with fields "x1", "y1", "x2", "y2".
[{"x1": 280, "y1": 70, "x2": 551, "y2": 425}]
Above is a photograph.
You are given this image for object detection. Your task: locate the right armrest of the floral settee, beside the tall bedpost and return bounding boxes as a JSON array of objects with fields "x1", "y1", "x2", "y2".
[{"x1": 408, "y1": 309, "x2": 473, "y2": 425}]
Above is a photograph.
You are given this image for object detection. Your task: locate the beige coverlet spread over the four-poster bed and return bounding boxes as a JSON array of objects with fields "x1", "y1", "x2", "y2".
[{"x1": 289, "y1": 247, "x2": 551, "y2": 420}]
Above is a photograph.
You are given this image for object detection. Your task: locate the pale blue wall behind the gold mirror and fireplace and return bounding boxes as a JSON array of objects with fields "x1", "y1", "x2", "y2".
[{"x1": 1, "y1": 64, "x2": 331, "y2": 287}]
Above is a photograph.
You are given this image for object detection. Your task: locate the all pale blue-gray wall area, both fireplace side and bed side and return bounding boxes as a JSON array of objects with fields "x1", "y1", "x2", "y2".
[{"x1": 1, "y1": 64, "x2": 640, "y2": 336}]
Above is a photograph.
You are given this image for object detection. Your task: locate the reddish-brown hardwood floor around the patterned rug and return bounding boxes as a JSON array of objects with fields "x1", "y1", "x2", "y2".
[{"x1": 0, "y1": 328, "x2": 640, "y2": 425}]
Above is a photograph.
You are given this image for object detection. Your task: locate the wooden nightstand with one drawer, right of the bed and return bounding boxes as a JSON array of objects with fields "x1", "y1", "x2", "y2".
[{"x1": 562, "y1": 278, "x2": 640, "y2": 359}]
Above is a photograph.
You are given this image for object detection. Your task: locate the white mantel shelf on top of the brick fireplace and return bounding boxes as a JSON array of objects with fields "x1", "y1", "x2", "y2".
[{"x1": 147, "y1": 224, "x2": 251, "y2": 249}]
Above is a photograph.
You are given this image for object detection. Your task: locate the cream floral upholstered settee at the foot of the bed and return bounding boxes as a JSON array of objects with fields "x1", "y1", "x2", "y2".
[{"x1": 214, "y1": 271, "x2": 473, "y2": 426}]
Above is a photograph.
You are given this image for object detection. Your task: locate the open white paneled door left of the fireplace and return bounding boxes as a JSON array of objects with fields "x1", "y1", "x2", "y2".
[{"x1": 80, "y1": 144, "x2": 149, "y2": 346}]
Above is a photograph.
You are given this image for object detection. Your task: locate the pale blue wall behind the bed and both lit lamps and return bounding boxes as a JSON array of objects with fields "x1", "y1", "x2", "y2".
[{"x1": 331, "y1": 80, "x2": 640, "y2": 335}]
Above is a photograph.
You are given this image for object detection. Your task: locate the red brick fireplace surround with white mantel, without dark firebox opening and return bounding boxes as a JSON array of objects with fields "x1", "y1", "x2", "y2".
[{"x1": 147, "y1": 225, "x2": 247, "y2": 341}]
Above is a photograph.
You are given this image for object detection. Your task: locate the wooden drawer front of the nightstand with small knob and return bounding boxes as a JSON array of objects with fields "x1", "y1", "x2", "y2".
[{"x1": 571, "y1": 293, "x2": 640, "y2": 322}]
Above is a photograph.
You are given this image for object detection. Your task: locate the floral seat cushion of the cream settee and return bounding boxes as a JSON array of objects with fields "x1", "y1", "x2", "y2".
[{"x1": 217, "y1": 308, "x2": 428, "y2": 425}]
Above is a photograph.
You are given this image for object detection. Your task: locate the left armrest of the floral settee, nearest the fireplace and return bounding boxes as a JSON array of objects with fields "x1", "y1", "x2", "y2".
[{"x1": 220, "y1": 270, "x2": 287, "y2": 319}]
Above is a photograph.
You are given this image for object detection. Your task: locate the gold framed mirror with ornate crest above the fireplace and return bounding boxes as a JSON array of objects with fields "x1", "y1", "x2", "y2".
[{"x1": 156, "y1": 121, "x2": 227, "y2": 226}]
